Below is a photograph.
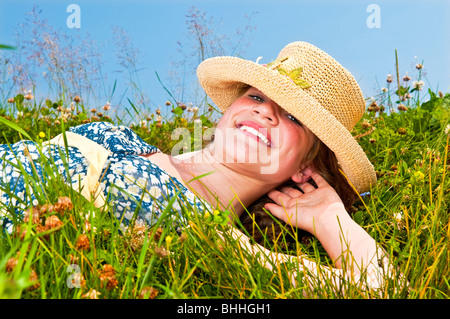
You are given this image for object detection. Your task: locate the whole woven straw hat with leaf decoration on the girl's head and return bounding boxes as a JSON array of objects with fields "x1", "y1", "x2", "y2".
[{"x1": 197, "y1": 42, "x2": 376, "y2": 193}]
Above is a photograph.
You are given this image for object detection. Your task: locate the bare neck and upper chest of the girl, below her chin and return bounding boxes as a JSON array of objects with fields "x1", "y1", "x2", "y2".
[{"x1": 171, "y1": 149, "x2": 277, "y2": 217}]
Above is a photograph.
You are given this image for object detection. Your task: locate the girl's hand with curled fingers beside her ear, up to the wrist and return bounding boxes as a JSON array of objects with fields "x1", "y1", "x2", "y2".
[{"x1": 264, "y1": 171, "x2": 348, "y2": 234}]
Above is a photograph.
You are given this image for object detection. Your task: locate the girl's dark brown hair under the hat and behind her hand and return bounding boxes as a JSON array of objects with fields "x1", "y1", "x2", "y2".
[{"x1": 240, "y1": 139, "x2": 358, "y2": 250}]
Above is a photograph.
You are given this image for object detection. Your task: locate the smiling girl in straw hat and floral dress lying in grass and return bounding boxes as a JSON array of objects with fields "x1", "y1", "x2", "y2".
[{"x1": 0, "y1": 42, "x2": 381, "y2": 292}]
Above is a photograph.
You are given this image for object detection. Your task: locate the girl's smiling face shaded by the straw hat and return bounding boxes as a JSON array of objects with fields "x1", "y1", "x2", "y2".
[{"x1": 213, "y1": 87, "x2": 316, "y2": 182}]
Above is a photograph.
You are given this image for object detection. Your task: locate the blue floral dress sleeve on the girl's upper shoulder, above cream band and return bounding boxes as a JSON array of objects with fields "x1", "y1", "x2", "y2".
[{"x1": 69, "y1": 122, "x2": 160, "y2": 155}]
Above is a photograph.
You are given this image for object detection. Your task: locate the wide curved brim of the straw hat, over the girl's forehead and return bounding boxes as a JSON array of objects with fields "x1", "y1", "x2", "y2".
[{"x1": 197, "y1": 56, "x2": 376, "y2": 193}]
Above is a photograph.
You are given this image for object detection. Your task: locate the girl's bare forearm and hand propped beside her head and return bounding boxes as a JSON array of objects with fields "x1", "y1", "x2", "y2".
[{"x1": 265, "y1": 172, "x2": 381, "y2": 272}]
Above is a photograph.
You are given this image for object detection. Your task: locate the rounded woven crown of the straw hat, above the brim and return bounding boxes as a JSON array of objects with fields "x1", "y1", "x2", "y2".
[{"x1": 276, "y1": 42, "x2": 365, "y2": 131}]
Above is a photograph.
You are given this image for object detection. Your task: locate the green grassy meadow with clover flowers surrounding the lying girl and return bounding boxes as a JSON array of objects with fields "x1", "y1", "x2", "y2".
[{"x1": 0, "y1": 7, "x2": 450, "y2": 299}]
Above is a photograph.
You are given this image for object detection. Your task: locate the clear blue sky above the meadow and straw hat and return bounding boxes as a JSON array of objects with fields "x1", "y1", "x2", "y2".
[{"x1": 0, "y1": 0, "x2": 450, "y2": 109}]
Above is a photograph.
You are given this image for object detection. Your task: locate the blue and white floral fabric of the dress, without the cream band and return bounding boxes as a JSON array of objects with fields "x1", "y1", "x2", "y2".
[{"x1": 0, "y1": 122, "x2": 210, "y2": 233}]
